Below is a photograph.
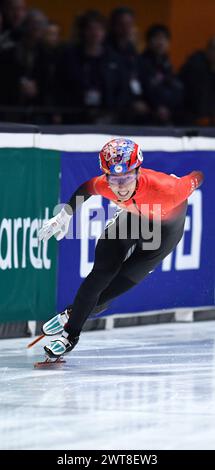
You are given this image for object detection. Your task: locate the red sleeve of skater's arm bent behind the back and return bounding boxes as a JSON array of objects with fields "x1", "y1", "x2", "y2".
[{"x1": 172, "y1": 171, "x2": 204, "y2": 206}]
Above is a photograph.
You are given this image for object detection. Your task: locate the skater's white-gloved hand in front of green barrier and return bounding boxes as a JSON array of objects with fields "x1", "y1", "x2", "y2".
[{"x1": 38, "y1": 209, "x2": 72, "y2": 242}]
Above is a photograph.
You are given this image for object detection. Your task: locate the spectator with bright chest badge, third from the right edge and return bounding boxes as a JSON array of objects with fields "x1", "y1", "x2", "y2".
[{"x1": 108, "y1": 7, "x2": 150, "y2": 124}]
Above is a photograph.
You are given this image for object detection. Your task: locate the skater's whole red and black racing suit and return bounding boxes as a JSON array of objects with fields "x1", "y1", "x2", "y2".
[{"x1": 65, "y1": 168, "x2": 203, "y2": 337}]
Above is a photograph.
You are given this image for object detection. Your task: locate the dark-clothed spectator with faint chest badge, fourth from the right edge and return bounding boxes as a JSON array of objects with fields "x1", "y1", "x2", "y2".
[{"x1": 54, "y1": 11, "x2": 127, "y2": 123}]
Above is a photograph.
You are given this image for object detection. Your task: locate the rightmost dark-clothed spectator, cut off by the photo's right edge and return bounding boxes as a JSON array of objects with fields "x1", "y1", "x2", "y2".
[{"x1": 180, "y1": 37, "x2": 215, "y2": 125}]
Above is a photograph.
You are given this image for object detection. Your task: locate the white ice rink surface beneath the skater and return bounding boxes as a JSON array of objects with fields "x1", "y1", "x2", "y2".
[{"x1": 0, "y1": 322, "x2": 215, "y2": 450}]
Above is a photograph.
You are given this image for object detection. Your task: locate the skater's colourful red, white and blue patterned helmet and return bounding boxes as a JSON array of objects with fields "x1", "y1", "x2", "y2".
[{"x1": 99, "y1": 138, "x2": 143, "y2": 175}]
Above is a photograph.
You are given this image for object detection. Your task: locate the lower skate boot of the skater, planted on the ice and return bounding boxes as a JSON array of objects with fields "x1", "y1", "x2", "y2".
[{"x1": 44, "y1": 331, "x2": 79, "y2": 359}]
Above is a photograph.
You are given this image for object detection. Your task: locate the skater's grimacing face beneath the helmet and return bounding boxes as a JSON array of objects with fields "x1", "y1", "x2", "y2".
[{"x1": 107, "y1": 170, "x2": 137, "y2": 201}]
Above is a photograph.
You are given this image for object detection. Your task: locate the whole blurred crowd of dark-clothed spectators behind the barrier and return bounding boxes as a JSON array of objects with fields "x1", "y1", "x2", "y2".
[{"x1": 0, "y1": 0, "x2": 215, "y2": 126}]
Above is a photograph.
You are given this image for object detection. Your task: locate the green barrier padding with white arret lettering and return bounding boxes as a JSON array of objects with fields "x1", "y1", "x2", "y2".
[{"x1": 0, "y1": 147, "x2": 60, "y2": 321}]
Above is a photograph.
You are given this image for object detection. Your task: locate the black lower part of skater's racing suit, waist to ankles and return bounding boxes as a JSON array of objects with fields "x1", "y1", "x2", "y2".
[{"x1": 65, "y1": 206, "x2": 186, "y2": 336}]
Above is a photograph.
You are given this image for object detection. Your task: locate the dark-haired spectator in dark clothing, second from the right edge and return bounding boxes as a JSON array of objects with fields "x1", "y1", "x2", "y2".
[{"x1": 141, "y1": 25, "x2": 183, "y2": 125}]
